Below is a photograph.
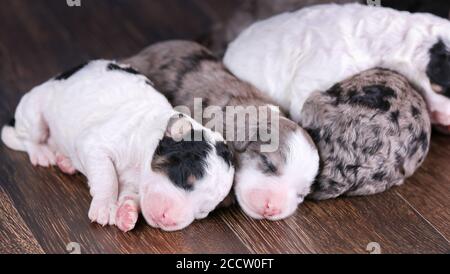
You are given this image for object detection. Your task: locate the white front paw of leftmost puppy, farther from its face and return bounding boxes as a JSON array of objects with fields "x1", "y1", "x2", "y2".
[{"x1": 88, "y1": 198, "x2": 117, "y2": 226}]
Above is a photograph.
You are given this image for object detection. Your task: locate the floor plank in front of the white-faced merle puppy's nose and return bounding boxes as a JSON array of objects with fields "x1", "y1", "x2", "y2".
[{"x1": 221, "y1": 191, "x2": 450, "y2": 253}]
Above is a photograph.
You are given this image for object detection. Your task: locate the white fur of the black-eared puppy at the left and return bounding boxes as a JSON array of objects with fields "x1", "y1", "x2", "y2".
[{"x1": 2, "y1": 60, "x2": 234, "y2": 230}]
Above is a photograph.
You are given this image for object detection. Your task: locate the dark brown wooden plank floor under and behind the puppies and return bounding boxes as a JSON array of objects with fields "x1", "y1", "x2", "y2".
[{"x1": 0, "y1": 0, "x2": 450, "y2": 253}]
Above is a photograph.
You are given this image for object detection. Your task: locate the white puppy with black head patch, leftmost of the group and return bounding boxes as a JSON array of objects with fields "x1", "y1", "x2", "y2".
[{"x1": 2, "y1": 60, "x2": 234, "y2": 231}]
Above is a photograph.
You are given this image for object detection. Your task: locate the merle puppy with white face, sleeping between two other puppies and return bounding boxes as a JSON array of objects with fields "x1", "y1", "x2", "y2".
[{"x1": 123, "y1": 41, "x2": 319, "y2": 220}]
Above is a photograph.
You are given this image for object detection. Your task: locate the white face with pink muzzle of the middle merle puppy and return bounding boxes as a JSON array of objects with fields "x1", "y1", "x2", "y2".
[{"x1": 235, "y1": 117, "x2": 319, "y2": 220}]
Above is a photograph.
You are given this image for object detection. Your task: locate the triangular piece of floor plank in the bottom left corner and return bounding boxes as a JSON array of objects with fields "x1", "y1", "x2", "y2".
[{"x1": 0, "y1": 188, "x2": 44, "y2": 254}]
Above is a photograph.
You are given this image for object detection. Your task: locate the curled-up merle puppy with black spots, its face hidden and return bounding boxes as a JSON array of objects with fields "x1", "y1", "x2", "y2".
[{"x1": 300, "y1": 69, "x2": 431, "y2": 199}]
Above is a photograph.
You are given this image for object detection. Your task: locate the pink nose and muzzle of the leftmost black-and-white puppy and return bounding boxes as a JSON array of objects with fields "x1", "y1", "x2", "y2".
[{"x1": 143, "y1": 193, "x2": 183, "y2": 227}]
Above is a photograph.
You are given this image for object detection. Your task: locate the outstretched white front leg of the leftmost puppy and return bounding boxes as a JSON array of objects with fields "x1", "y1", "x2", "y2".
[{"x1": 86, "y1": 152, "x2": 119, "y2": 226}]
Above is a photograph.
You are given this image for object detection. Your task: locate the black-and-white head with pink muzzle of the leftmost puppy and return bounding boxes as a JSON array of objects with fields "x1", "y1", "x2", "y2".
[{"x1": 141, "y1": 114, "x2": 234, "y2": 231}]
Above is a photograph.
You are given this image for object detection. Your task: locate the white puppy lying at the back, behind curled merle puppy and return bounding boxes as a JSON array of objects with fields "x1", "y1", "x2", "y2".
[{"x1": 224, "y1": 4, "x2": 450, "y2": 131}]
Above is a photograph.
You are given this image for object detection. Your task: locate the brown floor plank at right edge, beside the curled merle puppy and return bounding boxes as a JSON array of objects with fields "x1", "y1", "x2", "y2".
[{"x1": 396, "y1": 132, "x2": 450, "y2": 241}]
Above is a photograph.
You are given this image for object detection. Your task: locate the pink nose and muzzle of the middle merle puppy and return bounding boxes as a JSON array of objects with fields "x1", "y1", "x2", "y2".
[{"x1": 247, "y1": 189, "x2": 287, "y2": 218}]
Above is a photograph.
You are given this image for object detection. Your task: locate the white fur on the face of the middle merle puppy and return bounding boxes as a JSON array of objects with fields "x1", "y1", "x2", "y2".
[{"x1": 235, "y1": 127, "x2": 319, "y2": 221}]
